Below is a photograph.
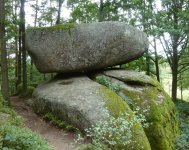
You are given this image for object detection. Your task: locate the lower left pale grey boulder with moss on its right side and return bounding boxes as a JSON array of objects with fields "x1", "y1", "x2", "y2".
[{"x1": 33, "y1": 74, "x2": 151, "y2": 150}]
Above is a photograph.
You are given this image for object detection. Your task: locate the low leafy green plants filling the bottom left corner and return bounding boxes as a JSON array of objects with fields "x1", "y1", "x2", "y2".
[{"x1": 0, "y1": 123, "x2": 53, "y2": 150}]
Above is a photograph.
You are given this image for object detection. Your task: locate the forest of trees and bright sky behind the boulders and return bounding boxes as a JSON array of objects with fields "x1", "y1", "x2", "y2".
[{"x1": 0, "y1": 0, "x2": 189, "y2": 104}]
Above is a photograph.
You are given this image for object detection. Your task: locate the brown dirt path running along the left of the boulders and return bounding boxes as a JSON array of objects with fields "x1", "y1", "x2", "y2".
[{"x1": 11, "y1": 96, "x2": 90, "y2": 150}]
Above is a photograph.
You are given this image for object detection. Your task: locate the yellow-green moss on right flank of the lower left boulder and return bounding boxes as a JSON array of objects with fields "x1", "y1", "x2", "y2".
[{"x1": 96, "y1": 86, "x2": 151, "y2": 150}]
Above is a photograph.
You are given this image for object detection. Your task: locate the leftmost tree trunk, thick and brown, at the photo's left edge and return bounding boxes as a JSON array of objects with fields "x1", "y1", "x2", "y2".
[{"x1": 0, "y1": 0, "x2": 10, "y2": 105}]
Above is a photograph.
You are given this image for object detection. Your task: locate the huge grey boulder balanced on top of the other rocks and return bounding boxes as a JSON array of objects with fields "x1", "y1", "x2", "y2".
[{"x1": 26, "y1": 21, "x2": 149, "y2": 73}]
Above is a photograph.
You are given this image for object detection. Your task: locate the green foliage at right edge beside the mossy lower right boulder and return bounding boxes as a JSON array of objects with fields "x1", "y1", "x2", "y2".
[{"x1": 175, "y1": 100, "x2": 189, "y2": 150}]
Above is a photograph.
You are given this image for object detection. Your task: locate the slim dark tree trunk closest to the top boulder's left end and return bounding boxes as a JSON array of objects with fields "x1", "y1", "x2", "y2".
[{"x1": 21, "y1": 0, "x2": 27, "y2": 96}]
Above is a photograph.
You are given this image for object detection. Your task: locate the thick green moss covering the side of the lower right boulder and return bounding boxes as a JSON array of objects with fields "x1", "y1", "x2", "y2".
[{"x1": 124, "y1": 78, "x2": 179, "y2": 150}]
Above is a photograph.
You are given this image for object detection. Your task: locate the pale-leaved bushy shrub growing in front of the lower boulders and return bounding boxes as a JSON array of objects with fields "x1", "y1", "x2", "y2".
[{"x1": 70, "y1": 107, "x2": 148, "y2": 150}]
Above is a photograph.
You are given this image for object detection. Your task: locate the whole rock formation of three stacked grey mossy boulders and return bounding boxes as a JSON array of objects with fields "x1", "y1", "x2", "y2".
[{"x1": 26, "y1": 21, "x2": 178, "y2": 150}]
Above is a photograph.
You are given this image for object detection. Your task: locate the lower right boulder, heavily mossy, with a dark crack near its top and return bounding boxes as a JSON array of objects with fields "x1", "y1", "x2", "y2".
[{"x1": 89, "y1": 69, "x2": 179, "y2": 150}]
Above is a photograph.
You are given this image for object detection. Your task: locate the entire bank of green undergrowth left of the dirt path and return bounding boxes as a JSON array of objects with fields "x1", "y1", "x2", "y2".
[{"x1": 0, "y1": 94, "x2": 54, "y2": 150}]
